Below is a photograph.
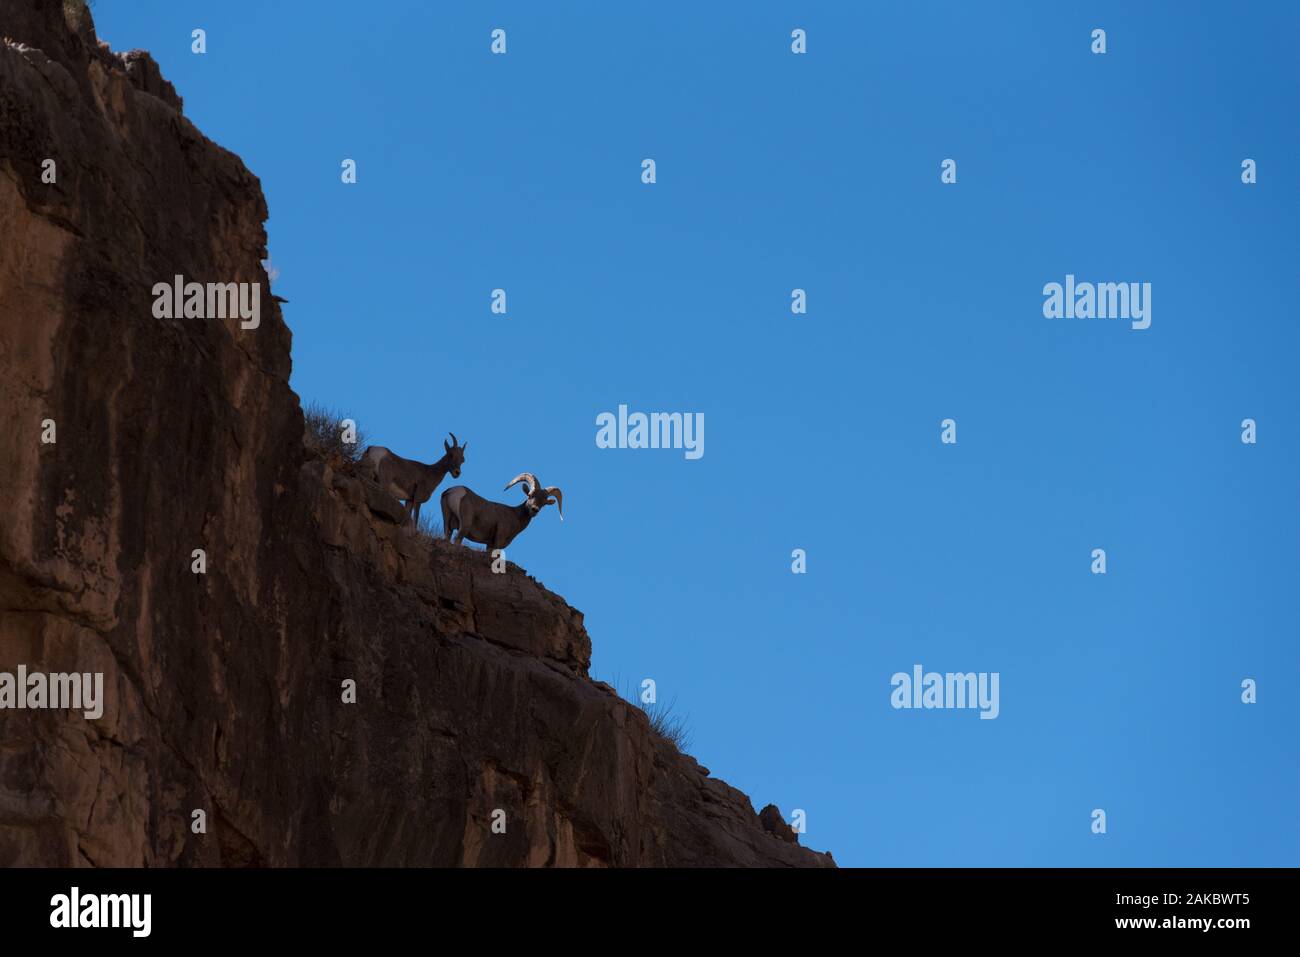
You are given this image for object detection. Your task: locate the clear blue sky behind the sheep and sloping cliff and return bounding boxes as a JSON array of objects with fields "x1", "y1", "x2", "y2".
[{"x1": 95, "y1": 0, "x2": 1300, "y2": 866}]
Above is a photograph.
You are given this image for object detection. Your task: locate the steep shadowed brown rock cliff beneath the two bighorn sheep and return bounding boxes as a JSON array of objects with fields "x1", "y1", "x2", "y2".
[{"x1": 0, "y1": 0, "x2": 832, "y2": 866}]
